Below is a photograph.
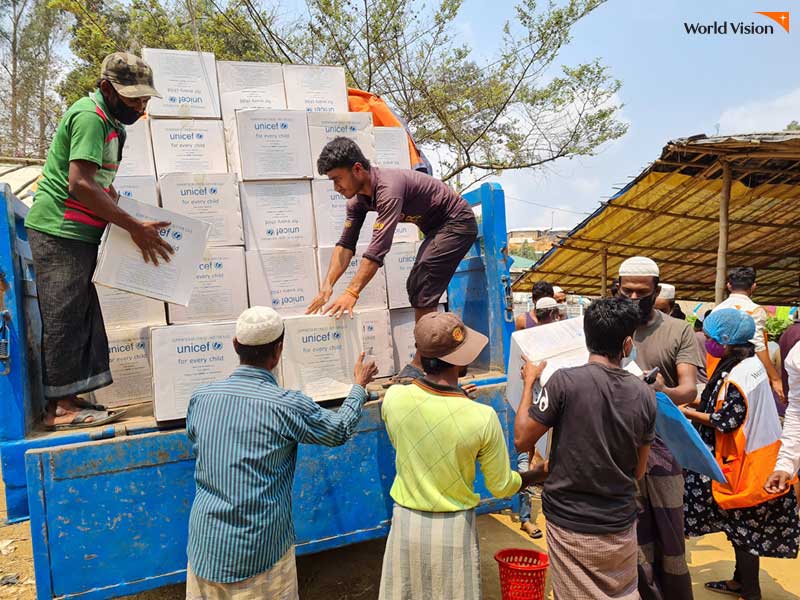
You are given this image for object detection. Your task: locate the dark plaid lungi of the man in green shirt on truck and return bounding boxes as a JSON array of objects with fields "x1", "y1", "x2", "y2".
[{"x1": 27, "y1": 229, "x2": 112, "y2": 398}]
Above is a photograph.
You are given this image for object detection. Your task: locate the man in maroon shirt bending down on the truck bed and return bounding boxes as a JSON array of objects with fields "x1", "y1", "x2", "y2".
[{"x1": 306, "y1": 137, "x2": 478, "y2": 380}]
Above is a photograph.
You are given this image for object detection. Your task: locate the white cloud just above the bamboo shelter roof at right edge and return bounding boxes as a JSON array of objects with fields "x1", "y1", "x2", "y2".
[{"x1": 719, "y1": 88, "x2": 800, "y2": 134}]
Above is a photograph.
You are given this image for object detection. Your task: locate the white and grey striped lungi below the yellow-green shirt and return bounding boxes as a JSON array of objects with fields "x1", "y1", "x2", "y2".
[{"x1": 379, "y1": 504, "x2": 481, "y2": 600}]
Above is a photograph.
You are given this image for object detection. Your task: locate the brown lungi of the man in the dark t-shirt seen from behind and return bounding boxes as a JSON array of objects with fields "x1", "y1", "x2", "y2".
[{"x1": 547, "y1": 521, "x2": 639, "y2": 600}]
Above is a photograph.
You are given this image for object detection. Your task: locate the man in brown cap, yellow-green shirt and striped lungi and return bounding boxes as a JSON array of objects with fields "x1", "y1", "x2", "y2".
[{"x1": 380, "y1": 313, "x2": 545, "y2": 600}]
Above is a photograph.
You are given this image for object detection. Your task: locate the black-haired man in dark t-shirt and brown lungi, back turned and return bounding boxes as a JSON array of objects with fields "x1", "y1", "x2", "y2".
[{"x1": 514, "y1": 298, "x2": 656, "y2": 600}]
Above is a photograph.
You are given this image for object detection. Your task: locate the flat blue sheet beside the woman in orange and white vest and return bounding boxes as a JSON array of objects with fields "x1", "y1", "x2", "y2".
[{"x1": 656, "y1": 392, "x2": 726, "y2": 483}]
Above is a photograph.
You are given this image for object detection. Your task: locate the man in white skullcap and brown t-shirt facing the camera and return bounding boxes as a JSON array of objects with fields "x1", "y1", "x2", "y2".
[{"x1": 617, "y1": 256, "x2": 704, "y2": 600}]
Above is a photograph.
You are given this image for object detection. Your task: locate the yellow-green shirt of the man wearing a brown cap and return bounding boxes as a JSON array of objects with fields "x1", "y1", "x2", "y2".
[{"x1": 381, "y1": 379, "x2": 522, "y2": 512}]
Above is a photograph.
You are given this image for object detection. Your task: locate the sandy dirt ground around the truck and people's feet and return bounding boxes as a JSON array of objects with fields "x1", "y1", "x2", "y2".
[{"x1": 0, "y1": 474, "x2": 800, "y2": 600}]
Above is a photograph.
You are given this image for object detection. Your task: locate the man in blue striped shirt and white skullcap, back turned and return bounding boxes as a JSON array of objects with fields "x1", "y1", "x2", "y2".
[{"x1": 186, "y1": 306, "x2": 377, "y2": 600}]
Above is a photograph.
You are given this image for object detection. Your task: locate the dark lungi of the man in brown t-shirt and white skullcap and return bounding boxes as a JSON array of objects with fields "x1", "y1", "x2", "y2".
[{"x1": 636, "y1": 439, "x2": 694, "y2": 600}]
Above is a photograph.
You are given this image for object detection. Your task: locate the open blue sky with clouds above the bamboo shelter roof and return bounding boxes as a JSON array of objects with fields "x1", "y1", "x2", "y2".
[{"x1": 456, "y1": 0, "x2": 800, "y2": 229}]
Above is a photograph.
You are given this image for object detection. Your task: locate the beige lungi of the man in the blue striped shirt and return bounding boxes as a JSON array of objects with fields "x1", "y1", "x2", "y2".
[{"x1": 186, "y1": 546, "x2": 299, "y2": 600}]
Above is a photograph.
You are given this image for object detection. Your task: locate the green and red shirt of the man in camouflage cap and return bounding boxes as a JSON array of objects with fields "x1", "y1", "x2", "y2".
[{"x1": 25, "y1": 90, "x2": 125, "y2": 244}]
